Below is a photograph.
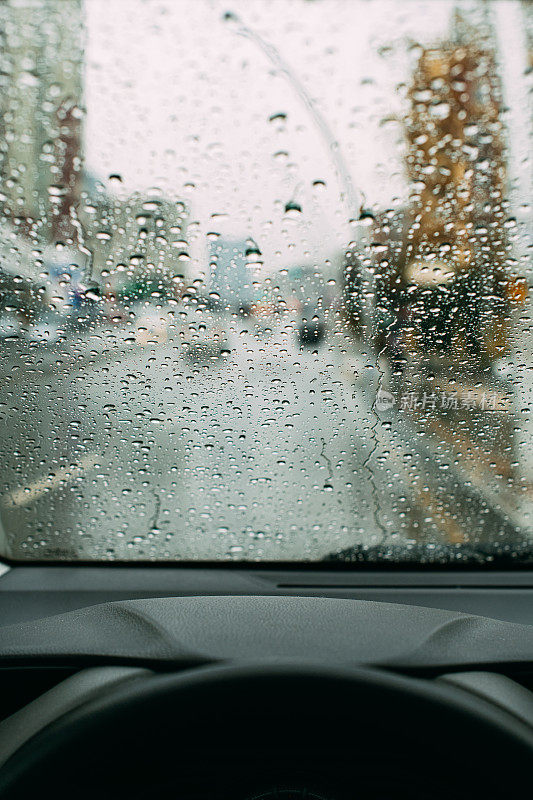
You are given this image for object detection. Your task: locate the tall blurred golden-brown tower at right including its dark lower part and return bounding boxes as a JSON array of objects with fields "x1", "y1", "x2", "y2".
[{"x1": 344, "y1": 12, "x2": 527, "y2": 378}]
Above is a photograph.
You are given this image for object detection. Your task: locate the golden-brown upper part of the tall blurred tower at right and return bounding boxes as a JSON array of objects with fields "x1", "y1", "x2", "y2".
[{"x1": 405, "y1": 8, "x2": 506, "y2": 278}]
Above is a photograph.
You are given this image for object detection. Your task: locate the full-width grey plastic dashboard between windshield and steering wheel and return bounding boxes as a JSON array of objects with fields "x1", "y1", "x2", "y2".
[{"x1": 0, "y1": 565, "x2": 533, "y2": 685}]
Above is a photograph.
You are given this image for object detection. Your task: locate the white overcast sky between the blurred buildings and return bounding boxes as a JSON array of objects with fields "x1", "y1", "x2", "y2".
[{"x1": 81, "y1": 0, "x2": 492, "y2": 268}]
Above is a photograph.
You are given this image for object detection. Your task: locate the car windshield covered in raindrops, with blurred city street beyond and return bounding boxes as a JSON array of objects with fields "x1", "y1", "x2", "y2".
[{"x1": 0, "y1": 0, "x2": 533, "y2": 565}]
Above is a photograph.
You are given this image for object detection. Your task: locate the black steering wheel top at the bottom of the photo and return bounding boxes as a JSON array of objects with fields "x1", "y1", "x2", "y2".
[{"x1": 0, "y1": 662, "x2": 533, "y2": 800}]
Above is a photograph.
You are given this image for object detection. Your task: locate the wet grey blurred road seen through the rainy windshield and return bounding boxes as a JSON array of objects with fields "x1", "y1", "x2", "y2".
[{"x1": 0, "y1": 321, "x2": 524, "y2": 560}]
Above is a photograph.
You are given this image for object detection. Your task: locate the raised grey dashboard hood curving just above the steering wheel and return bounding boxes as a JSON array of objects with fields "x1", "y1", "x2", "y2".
[{"x1": 0, "y1": 584, "x2": 533, "y2": 671}]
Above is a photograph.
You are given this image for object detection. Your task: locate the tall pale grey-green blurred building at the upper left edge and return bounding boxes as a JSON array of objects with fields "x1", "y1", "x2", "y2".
[{"x1": 0, "y1": 0, "x2": 83, "y2": 241}]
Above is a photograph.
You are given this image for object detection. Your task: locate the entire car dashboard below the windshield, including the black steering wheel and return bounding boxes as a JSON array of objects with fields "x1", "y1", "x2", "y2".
[{"x1": 0, "y1": 565, "x2": 533, "y2": 800}]
